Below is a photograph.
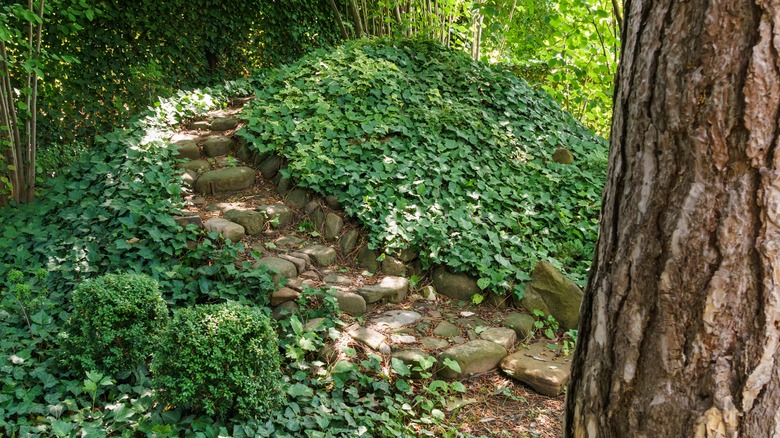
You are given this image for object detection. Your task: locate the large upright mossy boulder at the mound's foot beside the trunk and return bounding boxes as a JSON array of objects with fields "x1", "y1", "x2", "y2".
[{"x1": 520, "y1": 261, "x2": 582, "y2": 330}]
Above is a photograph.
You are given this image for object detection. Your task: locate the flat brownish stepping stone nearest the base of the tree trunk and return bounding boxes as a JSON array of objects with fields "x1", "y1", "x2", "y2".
[{"x1": 501, "y1": 343, "x2": 571, "y2": 397}]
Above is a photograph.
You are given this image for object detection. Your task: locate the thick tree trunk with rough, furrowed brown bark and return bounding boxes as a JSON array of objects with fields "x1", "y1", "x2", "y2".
[{"x1": 565, "y1": 0, "x2": 780, "y2": 438}]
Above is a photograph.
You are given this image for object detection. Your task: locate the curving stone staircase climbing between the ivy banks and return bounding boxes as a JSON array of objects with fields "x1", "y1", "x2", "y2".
[{"x1": 170, "y1": 102, "x2": 570, "y2": 396}]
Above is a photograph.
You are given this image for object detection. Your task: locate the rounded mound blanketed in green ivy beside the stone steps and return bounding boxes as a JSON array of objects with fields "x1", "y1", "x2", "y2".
[{"x1": 243, "y1": 40, "x2": 606, "y2": 292}]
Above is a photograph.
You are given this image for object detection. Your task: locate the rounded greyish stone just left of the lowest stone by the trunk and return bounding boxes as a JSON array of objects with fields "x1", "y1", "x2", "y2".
[{"x1": 437, "y1": 339, "x2": 507, "y2": 379}]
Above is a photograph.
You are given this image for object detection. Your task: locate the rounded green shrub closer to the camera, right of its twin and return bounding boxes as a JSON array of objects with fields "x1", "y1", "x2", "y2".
[{"x1": 152, "y1": 302, "x2": 283, "y2": 418}]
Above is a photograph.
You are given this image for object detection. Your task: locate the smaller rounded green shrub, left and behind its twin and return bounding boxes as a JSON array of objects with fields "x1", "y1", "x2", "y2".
[{"x1": 64, "y1": 274, "x2": 169, "y2": 374}]
